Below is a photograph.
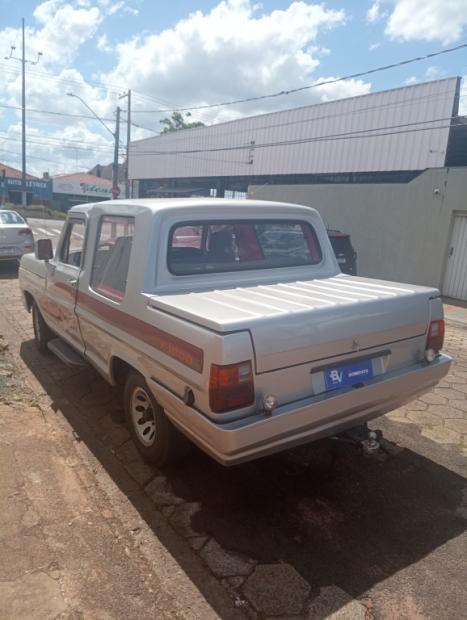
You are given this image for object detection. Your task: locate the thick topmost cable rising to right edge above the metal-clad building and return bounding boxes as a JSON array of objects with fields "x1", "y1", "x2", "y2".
[{"x1": 130, "y1": 43, "x2": 467, "y2": 114}]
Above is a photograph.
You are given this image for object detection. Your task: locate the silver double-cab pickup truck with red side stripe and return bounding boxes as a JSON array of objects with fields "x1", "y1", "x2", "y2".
[{"x1": 19, "y1": 198, "x2": 451, "y2": 465}]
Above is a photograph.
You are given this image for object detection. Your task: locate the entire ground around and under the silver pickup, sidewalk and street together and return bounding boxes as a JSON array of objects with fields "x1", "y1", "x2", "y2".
[{"x1": 0, "y1": 270, "x2": 467, "y2": 620}]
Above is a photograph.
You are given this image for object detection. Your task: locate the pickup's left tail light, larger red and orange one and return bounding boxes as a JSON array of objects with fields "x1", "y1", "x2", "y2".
[{"x1": 209, "y1": 361, "x2": 255, "y2": 413}]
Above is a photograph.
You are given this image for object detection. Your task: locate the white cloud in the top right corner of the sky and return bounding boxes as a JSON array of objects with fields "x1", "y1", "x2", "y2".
[{"x1": 386, "y1": 0, "x2": 467, "y2": 44}]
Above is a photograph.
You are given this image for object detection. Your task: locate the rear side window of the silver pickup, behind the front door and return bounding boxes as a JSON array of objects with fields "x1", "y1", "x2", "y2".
[{"x1": 91, "y1": 215, "x2": 135, "y2": 301}]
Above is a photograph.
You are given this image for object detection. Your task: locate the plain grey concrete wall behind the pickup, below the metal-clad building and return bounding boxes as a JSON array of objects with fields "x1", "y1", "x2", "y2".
[{"x1": 248, "y1": 168, "x2": 467, "y2": 288}]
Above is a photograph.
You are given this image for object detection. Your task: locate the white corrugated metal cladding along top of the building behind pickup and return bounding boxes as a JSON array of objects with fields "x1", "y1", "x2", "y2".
[{"x1": 129, "y1": 78, "x2": 460, "y2": 179}]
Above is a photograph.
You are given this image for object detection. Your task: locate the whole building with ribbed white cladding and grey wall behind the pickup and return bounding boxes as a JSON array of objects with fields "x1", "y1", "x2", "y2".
[{"x1": 129, "y1": 78, "x2": 467, "y2": 299}]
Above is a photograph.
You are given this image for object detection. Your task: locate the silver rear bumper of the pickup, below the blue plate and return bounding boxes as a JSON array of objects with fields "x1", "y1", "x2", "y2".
[{"x1": 157, "y1": 355, "x2": 451, "y2": 465}]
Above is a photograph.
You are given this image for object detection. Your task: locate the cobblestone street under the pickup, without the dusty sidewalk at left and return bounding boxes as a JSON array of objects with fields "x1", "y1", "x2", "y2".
[{"x1": 0, "y1": 270, "x2": 467, "y2": 620}]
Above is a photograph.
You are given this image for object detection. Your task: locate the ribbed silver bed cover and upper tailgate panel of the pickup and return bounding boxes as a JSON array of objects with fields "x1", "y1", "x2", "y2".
[{"x1": 149, "y1": 275, "x2": 439, "y2": 373}]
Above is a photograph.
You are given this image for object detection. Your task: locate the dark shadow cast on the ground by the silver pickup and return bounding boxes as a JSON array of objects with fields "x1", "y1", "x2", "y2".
[{"x1": 21, "y1": 340, "x2": 465, "y2": 618}]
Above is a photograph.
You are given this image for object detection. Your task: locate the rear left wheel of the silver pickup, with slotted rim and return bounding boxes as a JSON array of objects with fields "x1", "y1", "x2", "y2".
[{"x1": 123, "y1": 371, "x2": 191, "y2": 467}]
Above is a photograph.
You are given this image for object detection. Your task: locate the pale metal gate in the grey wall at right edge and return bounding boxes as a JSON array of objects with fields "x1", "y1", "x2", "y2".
[{"x1": 443, "y1": 214, "x2": 467, "y2": 300}]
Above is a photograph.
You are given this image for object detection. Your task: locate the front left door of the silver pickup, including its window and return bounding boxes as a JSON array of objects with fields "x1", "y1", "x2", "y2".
[{"x1": 41, "y1": 214, "x2": 86, "y2": 353}]
